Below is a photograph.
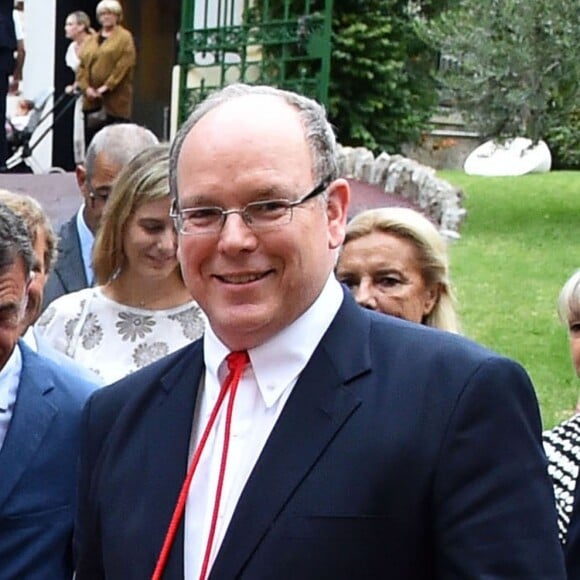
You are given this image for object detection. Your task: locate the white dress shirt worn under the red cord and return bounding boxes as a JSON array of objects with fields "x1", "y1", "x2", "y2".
[{"x1": 184, "y1": 274, "x2": 343, "y2": 580}]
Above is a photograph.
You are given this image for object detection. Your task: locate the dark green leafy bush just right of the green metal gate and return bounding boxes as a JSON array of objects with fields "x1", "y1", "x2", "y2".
[{"x1": 329, "y1": 0, "x2": 437, "y2": 152}]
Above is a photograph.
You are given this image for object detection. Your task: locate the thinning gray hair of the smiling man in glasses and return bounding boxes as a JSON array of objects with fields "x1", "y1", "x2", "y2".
[{"x1": 169, "y1": 83, "x2": 338, "y2": 199}]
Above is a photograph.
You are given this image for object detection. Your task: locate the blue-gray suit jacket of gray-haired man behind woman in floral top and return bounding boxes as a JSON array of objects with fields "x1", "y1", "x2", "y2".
[{"x1": 42, "y1": 214, "x2": 89, "y2": 310}]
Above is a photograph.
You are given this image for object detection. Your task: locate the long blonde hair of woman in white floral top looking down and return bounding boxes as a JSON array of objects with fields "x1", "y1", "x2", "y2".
[{"x1": 93, "y1": 144, "x2": 169, "y2": 285}]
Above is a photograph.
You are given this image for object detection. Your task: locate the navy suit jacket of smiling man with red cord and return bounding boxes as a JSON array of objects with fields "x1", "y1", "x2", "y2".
[{"x1": 76, "y1": 296, "x2": 565, "y2": 580}]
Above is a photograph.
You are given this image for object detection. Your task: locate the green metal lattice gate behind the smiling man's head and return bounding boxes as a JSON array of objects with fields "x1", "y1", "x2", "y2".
[{"x1": 178, "y1": 0, "x2": 332, "y2": 123}]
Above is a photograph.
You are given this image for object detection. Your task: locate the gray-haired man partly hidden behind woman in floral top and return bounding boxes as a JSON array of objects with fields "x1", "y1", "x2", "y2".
[{"x1": 42, "y1": 123, "x2": 159, "y2": 310}]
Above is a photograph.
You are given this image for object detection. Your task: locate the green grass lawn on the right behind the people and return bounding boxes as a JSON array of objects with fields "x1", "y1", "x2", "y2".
[{"x1": 439, "y1": 171, "x2": 580, "y2": 428}]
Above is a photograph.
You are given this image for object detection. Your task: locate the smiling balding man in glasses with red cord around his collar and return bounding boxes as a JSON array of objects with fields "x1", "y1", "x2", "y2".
[{"x1": 75, "y1": 85, "x2": 565, "y2": 580}]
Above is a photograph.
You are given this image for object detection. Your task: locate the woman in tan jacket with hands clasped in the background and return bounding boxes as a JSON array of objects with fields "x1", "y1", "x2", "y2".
[{"x1": 76, "y1": 0, "x2": 136, "y2": 146}]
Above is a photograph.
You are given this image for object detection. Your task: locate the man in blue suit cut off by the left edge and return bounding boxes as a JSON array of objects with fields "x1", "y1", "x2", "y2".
[{"x1": 0, "y1": 204, "x2": 94, "y2": 580}]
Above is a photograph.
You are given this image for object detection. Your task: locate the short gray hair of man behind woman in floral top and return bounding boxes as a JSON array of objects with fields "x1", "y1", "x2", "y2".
[{"x1": 85, "y1": 123, "x2": 159, "y2": 183}]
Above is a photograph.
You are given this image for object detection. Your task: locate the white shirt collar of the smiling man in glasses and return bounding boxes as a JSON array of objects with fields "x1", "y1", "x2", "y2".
[{"x1": 204, "y1": 273, "x2": 343, "y2": 407}]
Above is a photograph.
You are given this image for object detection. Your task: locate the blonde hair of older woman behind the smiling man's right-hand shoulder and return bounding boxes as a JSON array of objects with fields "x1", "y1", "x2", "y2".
[{"x1": 339, "y1": 207, "x2": 461, "y2": 333}]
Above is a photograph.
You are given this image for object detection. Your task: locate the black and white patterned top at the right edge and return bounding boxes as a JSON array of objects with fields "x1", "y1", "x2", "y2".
[{"x1": 543, "y1": 415, "x2": 580, "y2": 544}]
